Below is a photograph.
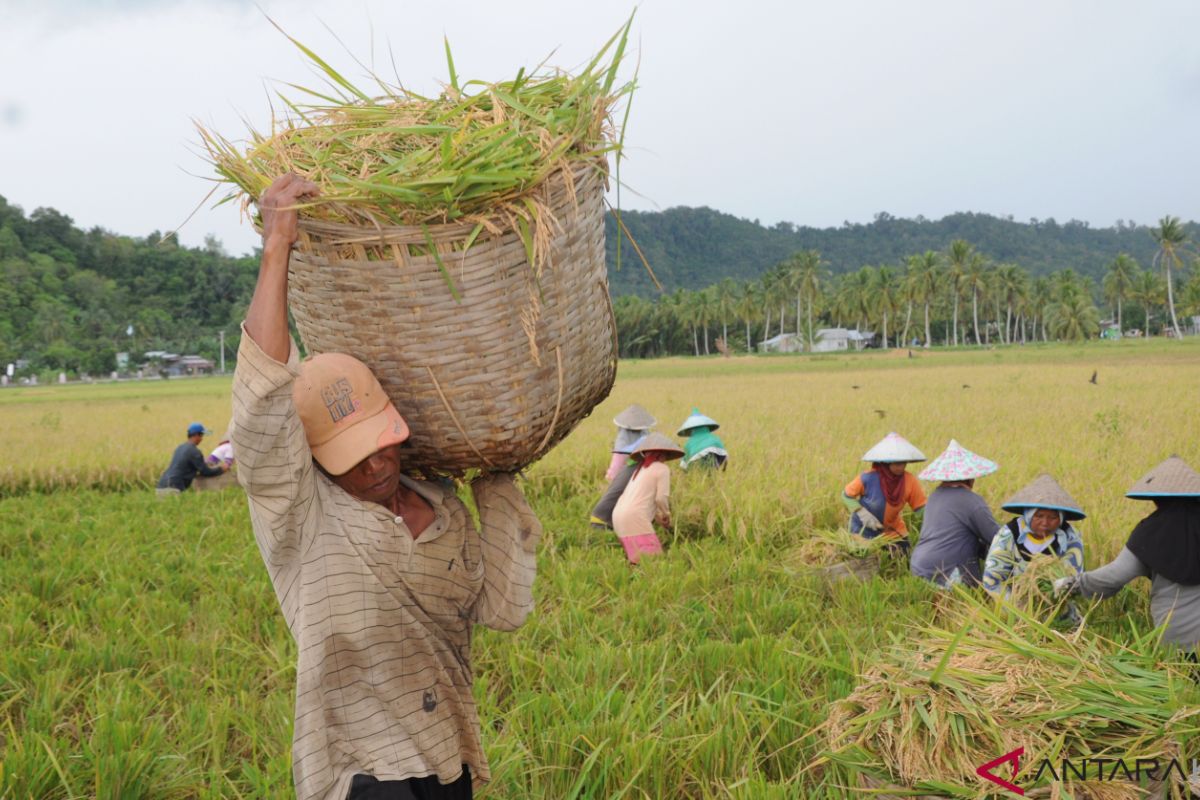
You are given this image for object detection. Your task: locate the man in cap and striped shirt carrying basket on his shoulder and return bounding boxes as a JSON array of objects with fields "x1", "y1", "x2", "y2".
[{"x1": 233, "y1": 175, "x2": 541, "y2": 800}]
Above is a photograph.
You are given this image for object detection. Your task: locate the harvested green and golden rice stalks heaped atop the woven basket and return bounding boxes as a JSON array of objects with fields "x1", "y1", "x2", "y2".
[{"x1": 197, "y1": 17, "x2": 634, "y2": 260}]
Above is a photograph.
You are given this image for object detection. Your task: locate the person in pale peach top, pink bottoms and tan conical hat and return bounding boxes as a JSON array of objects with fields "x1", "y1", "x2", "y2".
[{"x1": 612, "y1": 433, "x2": 683, "y2": 564}]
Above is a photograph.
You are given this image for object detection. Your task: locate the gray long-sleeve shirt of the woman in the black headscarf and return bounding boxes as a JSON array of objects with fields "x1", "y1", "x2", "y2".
[{"x1": 1075, "y1": 547, "x2": 1200, "y2": 648}]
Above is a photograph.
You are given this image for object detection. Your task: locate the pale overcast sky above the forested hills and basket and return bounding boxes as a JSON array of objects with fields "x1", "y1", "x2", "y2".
[{"x1": 0, "y1": 0, "x2": 1200, "y2": 253}]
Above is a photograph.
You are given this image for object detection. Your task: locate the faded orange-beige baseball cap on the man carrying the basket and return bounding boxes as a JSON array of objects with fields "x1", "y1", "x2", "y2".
[{"x1": 292, "y1": 353, "x2": 408, "y2": 475}]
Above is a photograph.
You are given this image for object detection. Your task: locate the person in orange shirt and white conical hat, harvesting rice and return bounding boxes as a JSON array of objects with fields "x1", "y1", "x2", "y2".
[{"x1": 841, "y1": 432, "x2": 925, "y2": 548}]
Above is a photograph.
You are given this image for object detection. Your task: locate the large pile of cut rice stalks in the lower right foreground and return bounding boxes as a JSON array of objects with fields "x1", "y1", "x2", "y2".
[{"x1": 822, "y1": 575, "x2": 1200, "y2": 798}]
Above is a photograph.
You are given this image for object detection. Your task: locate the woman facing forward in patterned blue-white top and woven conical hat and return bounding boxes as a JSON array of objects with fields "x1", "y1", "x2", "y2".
[{"x1": 983, "y1": 474, "x2": 1087, "y2": 597}]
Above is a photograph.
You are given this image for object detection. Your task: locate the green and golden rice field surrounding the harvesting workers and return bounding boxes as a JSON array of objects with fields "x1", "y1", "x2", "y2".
[{"x1": 0, "y1": 341, "x2": 1200, "y2": 800}]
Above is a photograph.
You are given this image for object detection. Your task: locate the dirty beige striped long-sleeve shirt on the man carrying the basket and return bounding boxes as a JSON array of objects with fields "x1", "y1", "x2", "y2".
[{"x1": 233, "y1": 332, "x2": 541, "y2": 800}]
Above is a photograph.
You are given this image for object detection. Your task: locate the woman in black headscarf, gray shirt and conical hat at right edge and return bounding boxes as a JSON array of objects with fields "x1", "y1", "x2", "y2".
[{"x1": 1055, "y1": 456, "x2": 1200, "y2": 658}]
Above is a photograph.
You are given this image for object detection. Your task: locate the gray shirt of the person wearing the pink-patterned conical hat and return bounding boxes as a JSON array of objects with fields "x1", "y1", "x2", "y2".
[{"x1": 908, "y1": 486, "x2": 1000, "y2": 584}]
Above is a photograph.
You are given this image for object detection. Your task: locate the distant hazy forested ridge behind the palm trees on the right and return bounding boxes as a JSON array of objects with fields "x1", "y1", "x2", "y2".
[{"x1": 607, "y1": 207, "x2": 1200, "y2": 296}]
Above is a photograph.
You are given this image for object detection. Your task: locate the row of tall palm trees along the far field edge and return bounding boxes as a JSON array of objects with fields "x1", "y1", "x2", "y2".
[{"x1": 614, "y1": 217, "x2": 1200, "y2": 357}]
